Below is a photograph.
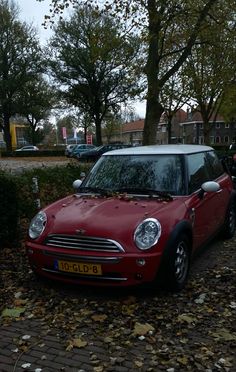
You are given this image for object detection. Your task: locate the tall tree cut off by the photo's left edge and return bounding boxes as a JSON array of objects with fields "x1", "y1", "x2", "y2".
[{"x1": 0, "y1": 0, "x2": 42, "y2": 150}]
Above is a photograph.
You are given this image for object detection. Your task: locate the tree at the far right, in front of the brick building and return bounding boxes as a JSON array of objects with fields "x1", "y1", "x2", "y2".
[{"x1": 185, "y1": 3, "x2": 236, "y2": 144}]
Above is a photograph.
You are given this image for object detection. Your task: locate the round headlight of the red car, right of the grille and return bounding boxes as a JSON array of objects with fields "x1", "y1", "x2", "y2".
[{"x1": 134, "y1": 218, "x2": 161, "y2": 250}]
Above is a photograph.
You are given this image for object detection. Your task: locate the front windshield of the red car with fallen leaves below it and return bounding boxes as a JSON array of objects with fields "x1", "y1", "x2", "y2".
[{"x1": 82, "y1": 155, "x2": 185, "y2": 195}]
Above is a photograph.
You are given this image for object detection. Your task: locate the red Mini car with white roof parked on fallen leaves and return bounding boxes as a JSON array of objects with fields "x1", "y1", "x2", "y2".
[{"x1": 26, "y1": 145, "x2": 236, "y2": 291}]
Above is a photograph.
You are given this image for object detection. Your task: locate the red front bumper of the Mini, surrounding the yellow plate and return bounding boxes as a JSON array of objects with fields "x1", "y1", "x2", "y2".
[{"x1": 26, "y1": 242, "x2": 161, "y2": 286}]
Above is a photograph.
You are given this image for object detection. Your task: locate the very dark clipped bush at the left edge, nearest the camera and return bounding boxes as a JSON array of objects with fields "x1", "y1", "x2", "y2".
[{"x1": 0, "y1": 172, "x2": 19, "y2": 247}]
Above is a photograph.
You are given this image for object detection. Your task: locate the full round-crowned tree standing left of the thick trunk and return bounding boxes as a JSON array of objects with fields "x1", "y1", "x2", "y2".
[{"x1": 48, "y1": 6, "x2": 138, "y2": 144}]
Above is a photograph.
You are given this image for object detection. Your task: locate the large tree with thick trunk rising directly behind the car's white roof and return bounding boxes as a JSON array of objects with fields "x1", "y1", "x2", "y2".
[{"x1": 39, "y1": 0, "x2": 225, "y2": 144}]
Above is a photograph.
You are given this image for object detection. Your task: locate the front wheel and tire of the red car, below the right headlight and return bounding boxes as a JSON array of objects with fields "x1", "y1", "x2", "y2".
[{"x1": 157, "y1": 234, "x2": 191, "y2": 292}]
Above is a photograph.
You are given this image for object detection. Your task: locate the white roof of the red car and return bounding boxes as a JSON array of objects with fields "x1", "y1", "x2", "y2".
[{"x1": 103, "y1": 144, "x2": 213, "y2": 156}]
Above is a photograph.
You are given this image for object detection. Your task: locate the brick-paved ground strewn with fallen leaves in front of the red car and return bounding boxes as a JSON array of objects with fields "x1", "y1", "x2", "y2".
[{"x1": 0, "y1": 238, "x2": 236, "y2": 372}]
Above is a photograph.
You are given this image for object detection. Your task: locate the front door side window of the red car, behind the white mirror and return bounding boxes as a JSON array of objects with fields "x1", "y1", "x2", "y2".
[{"x1": 188, "y1": 152, "x2": 210, "y2": 193}]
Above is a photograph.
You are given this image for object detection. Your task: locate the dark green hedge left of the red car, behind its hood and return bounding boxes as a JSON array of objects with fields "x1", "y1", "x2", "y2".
[{"x1": 0, "y1": 163, "x2": 91, "y2": 246}]
